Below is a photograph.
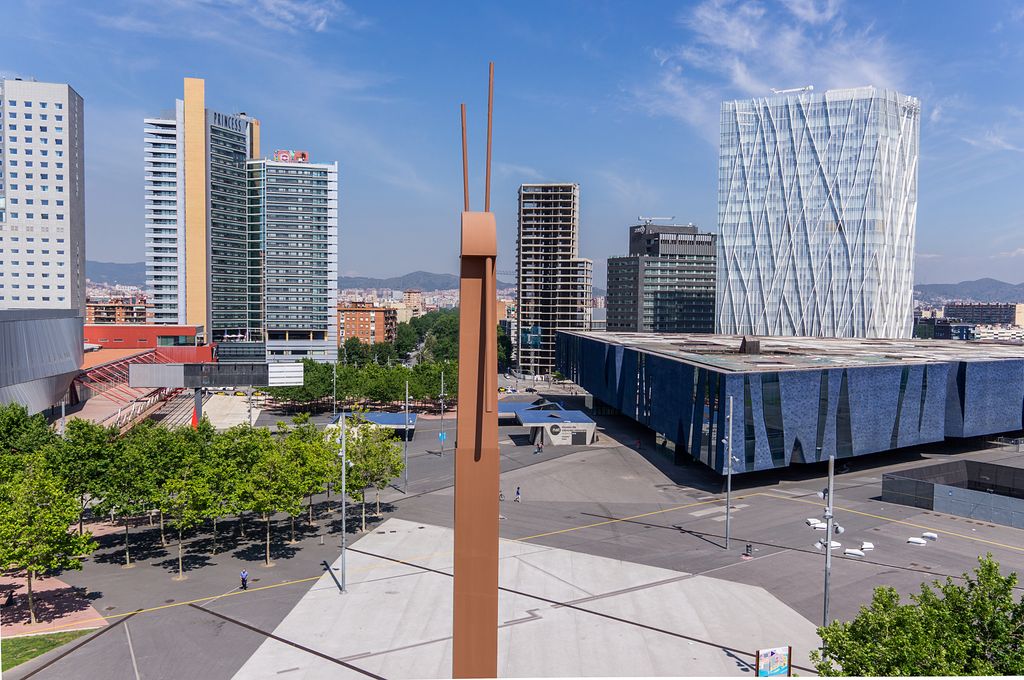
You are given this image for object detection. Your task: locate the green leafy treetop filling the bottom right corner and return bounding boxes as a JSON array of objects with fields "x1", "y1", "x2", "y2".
[{"x1": 811, "y1": 554, "x2": 1024, "y2": 676}]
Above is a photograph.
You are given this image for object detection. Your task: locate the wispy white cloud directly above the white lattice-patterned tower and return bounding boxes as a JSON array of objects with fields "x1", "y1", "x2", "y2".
[{"x1": 632, "y1": 0, "x2": 909, "y2": 143}]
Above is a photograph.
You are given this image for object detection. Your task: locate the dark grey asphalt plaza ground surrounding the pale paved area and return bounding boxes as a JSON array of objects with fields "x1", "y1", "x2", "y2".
[{"x1": 5, "y1": 378, "x2": 1024, "y2": 679}]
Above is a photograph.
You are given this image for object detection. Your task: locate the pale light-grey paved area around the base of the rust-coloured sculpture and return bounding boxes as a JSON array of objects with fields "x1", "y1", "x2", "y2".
[{"x1": 234, "y1": 519, "x2": 819, "y2": 680}]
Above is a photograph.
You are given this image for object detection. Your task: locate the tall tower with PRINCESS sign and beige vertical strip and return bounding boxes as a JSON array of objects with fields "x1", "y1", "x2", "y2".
[{"x1": 144, "y1": 78, "x2": 260, "y2": 340}]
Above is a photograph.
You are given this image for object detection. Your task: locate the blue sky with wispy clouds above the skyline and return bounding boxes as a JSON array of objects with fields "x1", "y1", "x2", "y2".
[{"x1": 0, "y1": 0, "x2": 1024, "y2": 286}]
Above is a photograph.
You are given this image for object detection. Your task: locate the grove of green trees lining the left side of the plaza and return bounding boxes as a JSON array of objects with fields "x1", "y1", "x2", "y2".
[{"x1": 0, "y1": 405, "x2": 403, "y2": 623}]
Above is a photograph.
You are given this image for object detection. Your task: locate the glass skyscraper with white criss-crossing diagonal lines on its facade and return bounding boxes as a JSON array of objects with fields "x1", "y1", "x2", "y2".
[{"x1": 717, "y1": 87, "x2": 921, "y2": 338}]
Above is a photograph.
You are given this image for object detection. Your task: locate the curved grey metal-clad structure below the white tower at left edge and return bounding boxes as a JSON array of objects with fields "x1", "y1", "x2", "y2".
[{"x1": 0, "y1": 309, "x2": 84, "y2": 413}]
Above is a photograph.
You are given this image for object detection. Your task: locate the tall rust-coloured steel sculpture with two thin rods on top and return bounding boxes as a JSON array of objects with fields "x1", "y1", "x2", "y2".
[{"x1": 452, "y1": 63, "x2": 501, "y2": 678}]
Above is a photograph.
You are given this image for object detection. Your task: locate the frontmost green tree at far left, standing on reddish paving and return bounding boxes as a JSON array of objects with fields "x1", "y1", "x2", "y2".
[{"x1": 0, "y1": 452, "x2": 96, "y2": 624}]
